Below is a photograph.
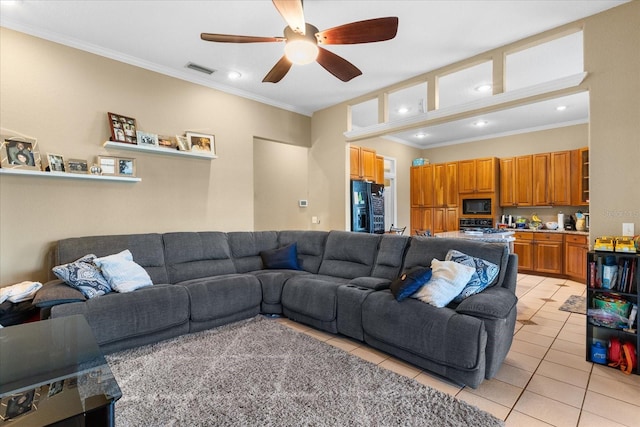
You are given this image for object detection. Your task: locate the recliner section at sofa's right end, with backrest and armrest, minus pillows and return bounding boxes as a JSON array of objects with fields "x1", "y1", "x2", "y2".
[{"x1": 362, "y1": 237, "x2": 517, "y2": 388}]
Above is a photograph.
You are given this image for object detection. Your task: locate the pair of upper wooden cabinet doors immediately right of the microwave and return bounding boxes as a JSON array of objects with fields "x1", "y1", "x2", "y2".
[{"x1": 500, "y1": 155, "x2": 533, "y2": 207}]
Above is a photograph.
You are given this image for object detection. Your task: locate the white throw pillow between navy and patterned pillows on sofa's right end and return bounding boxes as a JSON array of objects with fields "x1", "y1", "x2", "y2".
[{"x1": 413, "y1": 259, "x2": 475, "y2": 307}]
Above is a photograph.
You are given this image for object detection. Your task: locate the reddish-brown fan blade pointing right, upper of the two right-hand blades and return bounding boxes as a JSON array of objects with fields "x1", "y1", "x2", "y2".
[{"x1": 316, "y1": 16, "x2": 398, "y2": 44}]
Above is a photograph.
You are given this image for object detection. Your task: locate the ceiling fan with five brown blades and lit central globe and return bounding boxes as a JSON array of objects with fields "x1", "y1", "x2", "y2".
[{"x1": 200, "y1": 0, "x2": 398, "y2": 83}]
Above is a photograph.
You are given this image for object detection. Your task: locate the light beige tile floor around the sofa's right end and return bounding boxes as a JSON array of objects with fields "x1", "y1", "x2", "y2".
[{"x1": 280, "y1": 274, "x2": 640, "y2": 427}]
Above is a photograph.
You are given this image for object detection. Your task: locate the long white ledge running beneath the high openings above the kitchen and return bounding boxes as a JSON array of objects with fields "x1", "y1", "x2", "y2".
[{"x1": 344, "y1": 72, "x2": 587, "y2": 142}]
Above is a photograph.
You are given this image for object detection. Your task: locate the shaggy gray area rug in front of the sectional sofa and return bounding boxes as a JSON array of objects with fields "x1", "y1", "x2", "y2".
[{"x1": 107, "y1": 316, "x2": 504, "y2": 427}]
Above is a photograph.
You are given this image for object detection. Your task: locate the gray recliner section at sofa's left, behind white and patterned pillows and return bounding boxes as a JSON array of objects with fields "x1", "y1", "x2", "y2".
[{"x1": 51, "y1": 234, "x2": 190, "y2": 353}]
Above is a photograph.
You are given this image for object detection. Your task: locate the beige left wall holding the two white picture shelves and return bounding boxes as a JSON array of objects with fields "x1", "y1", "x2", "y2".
[{"x1": 0, "y1": 28, "x2": 311, "y2": 285}]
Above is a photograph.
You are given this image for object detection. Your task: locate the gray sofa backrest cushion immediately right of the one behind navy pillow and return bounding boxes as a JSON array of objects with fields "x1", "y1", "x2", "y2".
[{"x1": 318, "y1": 231, "x2": 381, "y2": 279}]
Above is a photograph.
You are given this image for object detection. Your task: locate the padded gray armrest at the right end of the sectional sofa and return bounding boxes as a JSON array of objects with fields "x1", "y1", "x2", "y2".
[{"x1": 455, "y1": 286, "x2": 518, "y2": 319}]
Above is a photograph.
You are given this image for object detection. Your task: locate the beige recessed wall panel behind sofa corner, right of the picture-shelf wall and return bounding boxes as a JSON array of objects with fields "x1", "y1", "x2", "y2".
[{"x1": 253, "y1": 138, "x2": 311, "y2": 230}]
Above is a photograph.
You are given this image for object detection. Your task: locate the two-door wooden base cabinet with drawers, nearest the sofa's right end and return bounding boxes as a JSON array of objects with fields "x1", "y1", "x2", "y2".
[{"x1": 513, "y1": 231, "x2": 564, "y2": 275}]
